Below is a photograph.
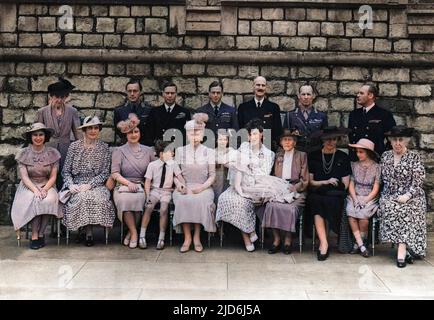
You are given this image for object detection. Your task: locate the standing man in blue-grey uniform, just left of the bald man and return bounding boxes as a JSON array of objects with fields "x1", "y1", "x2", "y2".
[{"x1": 197, "y1": 81, "x2": 238, "y2": 141}]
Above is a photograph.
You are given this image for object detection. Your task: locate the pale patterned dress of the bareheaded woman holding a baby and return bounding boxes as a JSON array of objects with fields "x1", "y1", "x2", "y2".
[{"x1": 216, "y1": 143, "x2": 274, "y2": 233}]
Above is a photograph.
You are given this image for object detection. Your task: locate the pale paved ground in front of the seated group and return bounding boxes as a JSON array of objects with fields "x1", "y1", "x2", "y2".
[{"x1": 0, "y1": 227, "x2": 434, "y2": 300}]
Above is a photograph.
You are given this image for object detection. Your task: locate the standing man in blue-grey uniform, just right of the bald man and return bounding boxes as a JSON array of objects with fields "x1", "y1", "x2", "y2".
[{"x1": 283, "y1": 84, "x2": 328, "y2": 153}]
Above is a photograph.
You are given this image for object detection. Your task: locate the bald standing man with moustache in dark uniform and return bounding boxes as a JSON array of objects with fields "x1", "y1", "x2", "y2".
[{"x1": 238, "y1": 76, "x2": 282, "y2": 149}]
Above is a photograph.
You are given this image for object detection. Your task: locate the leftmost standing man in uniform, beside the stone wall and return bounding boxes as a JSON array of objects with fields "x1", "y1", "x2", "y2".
[{"x1": 113, "y1": 79, "x2": 152, "y2": 144}]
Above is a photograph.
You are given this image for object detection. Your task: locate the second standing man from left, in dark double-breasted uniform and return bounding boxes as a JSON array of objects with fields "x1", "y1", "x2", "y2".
[{"x1": 147, "y1": 82, "x2": 191, "y2": 145}]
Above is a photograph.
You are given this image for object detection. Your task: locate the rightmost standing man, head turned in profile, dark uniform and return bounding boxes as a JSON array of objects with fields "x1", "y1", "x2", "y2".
[{"x1": 348, "y1": 84, "x2": 396, "y2": 161}]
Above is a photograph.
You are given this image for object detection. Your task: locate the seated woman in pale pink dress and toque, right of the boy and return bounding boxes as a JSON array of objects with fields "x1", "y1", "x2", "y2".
[{"x1": 173, "y1": 113, "x2": 216, "y2": 253}]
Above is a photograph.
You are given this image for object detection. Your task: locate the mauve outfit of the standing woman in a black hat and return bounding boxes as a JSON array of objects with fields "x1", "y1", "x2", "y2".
[{"x1": 37, "y1": 105, "x2": 80, "y2": 170}]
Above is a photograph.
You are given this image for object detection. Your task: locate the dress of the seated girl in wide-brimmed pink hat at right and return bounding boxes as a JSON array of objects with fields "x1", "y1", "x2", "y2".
[{"x1": 346, "y1": 161, "x2": 380, "y2": 219}]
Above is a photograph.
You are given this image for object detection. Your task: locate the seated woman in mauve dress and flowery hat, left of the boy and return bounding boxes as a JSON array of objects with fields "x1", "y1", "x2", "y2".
[{"x1": 111, "y1": 113, "x2": 155, "y2": 249}]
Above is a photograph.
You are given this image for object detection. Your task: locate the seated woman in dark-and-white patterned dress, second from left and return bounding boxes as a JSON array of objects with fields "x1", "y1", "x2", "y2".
[{"x1": 62, "y1": 116, "x2": 115, "y2": 247}]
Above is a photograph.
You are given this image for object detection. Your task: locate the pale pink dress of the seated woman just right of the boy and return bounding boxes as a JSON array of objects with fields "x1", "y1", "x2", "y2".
[{"x1": 173, "y1": 144, "x2": 216, "y2": 232}]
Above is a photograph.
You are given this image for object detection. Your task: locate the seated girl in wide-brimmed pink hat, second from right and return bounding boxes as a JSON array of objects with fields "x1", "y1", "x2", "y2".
[{"x1": 346, "y1": 139, "x2": 380, "y2": 258}]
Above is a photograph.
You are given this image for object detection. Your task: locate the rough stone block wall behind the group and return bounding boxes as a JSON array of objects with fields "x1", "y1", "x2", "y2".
[{"x1": 0, "y1": 0, "x2": 434, "y2": 229}]
